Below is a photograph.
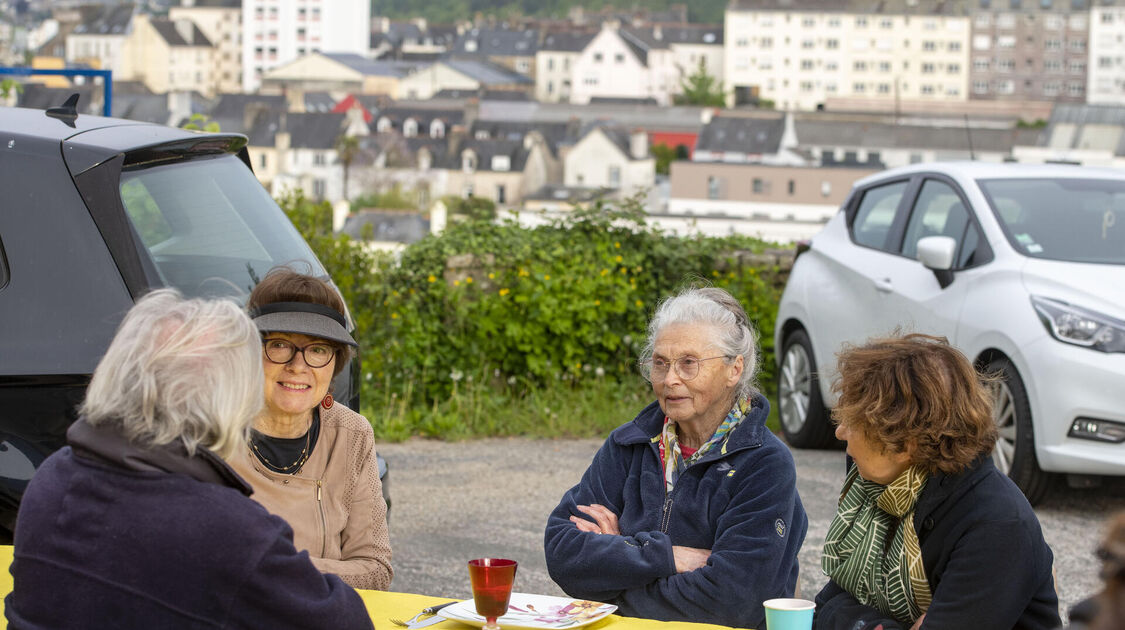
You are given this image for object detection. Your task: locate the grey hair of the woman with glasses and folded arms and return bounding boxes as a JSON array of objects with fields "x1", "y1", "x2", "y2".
[{"x1": 639, "y1": 287, "x2": 758, "y2": 397}]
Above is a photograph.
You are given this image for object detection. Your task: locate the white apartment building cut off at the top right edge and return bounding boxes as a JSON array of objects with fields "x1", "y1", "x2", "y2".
[{"x1": 1086, "y1": 3, "x2": 1125, "y2": 105}]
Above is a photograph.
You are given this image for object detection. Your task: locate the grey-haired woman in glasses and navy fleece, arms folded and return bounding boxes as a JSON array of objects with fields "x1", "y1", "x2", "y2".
[{"x1": 545, "y1": 288, "x2": 808, "y2": 628}]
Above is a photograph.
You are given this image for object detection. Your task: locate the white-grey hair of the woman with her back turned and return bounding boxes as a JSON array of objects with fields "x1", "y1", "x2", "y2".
[{"x1": 80, "y1": 289, "x2": 264, "y2": 459}]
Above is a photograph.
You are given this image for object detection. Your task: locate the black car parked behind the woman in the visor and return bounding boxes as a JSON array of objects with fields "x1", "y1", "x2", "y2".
[{"x1": 0, "y1": 99, "x2": 387, "y2": 541}]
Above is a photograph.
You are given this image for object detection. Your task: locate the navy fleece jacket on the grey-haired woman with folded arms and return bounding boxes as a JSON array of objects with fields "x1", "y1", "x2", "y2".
[{"x1": 546, "y1": 396, "x2": 808, "y2": 628}]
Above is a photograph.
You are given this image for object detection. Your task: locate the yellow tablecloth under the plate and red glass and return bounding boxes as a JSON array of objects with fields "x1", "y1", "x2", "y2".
[{"x1": 0, "y1": 545, "x2": 747, "y2": 630}]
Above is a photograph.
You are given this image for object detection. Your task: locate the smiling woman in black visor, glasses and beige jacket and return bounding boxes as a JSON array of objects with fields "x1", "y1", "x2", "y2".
[{"x1": 231, "y1": 268, "x2": 393, "y2": 591}]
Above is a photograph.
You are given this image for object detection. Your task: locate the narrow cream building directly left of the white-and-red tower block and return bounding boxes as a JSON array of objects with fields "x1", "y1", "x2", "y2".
[{"x1": 168, "y1": 0, "x2": 242, "y2": 93}]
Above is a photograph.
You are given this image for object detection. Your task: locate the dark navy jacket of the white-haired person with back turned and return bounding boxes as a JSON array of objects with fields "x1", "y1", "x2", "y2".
[{"x1": 5, "y1": 420, "x2": 371, "y2": 630}]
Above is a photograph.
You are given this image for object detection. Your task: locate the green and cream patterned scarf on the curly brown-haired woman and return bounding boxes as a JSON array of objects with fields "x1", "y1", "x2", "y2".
[{"x1": 821, "y1": 465, "x2": 932, "y2": 626}]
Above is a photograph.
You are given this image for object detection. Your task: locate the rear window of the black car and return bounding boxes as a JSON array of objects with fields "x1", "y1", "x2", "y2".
[{"x1": 120, "y1": 155, "x2": 325, "y2": 302}]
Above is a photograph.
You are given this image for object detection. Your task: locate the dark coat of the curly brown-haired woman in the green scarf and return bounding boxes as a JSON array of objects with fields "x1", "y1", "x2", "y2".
[{"x1": 813, "y1": 457, "x2": 1060, "y2": 630}]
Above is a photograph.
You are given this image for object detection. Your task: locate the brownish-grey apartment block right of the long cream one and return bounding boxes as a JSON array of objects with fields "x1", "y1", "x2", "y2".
[{"x1": 969, "y1": 0, "x2": 1090, "y2": 102}]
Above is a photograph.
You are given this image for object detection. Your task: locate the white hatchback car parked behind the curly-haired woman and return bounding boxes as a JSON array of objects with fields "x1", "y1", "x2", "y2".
[{"x1": 775, "y1": 162, "x2": 1125, "y2": 502}]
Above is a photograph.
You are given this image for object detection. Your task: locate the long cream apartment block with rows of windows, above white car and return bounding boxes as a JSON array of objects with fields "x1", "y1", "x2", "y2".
[{"x1": 723, "y1": 0, "x2": 971, "y2": 110}]
